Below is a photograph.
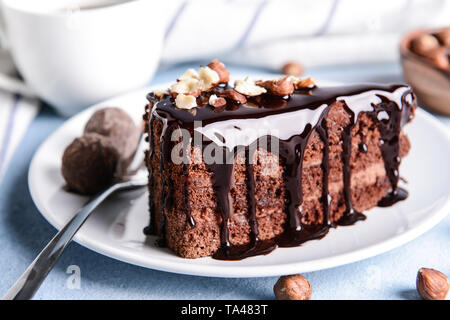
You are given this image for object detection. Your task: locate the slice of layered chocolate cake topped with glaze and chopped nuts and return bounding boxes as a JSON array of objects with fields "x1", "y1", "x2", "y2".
[{"x1": 144, "y1": 60, "x2": 416, "y2": 260}]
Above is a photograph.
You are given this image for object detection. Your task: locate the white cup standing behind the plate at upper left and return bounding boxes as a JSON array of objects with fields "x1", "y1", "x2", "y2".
[{"x1": 2, "y1": 0, "x2": 166, "y2": 115}]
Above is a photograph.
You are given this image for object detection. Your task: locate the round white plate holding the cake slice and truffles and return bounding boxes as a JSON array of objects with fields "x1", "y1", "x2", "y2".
[{"x1": 29, "y1": 85, "x2": 450, "y2": 277}]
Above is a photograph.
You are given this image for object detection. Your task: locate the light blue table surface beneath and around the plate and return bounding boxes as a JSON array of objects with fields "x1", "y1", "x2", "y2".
[{"x1": 0, "y1": 63, "x2": 450, "y2": 300}]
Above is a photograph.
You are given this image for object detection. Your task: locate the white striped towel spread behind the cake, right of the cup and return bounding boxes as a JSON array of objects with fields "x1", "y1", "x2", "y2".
[{"x1": 162, "y1": 0, "x2": 450, "y2": 70}]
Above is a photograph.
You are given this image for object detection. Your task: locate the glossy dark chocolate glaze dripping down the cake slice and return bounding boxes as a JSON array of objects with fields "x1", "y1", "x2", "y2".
[{"x1": 146, "y1": 85, "x2": 416, "y2": 260}]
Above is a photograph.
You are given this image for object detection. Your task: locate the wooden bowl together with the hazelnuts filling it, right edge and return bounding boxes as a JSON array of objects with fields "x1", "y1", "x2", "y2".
[{"x1": 400, "y1": 27, "x2": 450, "y2": 116}]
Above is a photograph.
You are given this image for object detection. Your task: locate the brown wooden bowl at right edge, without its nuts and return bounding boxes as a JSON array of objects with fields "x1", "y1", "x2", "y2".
[{"x1": 400, "y1": 29, "x2": 450, "y2": 116}]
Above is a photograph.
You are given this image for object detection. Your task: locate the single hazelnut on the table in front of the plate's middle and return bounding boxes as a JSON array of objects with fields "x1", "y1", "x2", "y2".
[{"x1": 273, "y1": 274, "x2": 312, "y2": 300}]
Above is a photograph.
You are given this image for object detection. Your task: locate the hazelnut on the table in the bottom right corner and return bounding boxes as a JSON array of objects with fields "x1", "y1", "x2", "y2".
[{"x1": 416, "y1": 268, "x2": 449, "y2": 300}]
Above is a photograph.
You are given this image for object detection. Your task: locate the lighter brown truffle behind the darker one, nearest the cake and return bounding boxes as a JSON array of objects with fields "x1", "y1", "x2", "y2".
[{"x1": 84, "y1": 107, "x2": 141, "y2": 167}]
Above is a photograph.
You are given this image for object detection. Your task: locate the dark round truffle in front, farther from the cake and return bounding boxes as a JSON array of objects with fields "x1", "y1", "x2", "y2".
[{"x1": 62, "y1": 133, "x2": 119, "y2": 195}]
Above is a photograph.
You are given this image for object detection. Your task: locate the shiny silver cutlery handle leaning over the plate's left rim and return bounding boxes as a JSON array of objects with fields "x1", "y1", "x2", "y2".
[{"x1": 3, "y1": 185, "x2": 118, "y2": 300}]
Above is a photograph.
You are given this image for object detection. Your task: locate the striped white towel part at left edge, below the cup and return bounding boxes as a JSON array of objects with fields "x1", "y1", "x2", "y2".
[{"x1": 0, "y1": 50, "x2": 40, "y2": 183}]
